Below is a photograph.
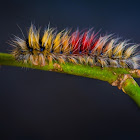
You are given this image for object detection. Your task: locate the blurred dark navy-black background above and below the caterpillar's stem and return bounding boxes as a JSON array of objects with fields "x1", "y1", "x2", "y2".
[{"x1": 0, "y1": 0, "x2": 140, "y2": 140}]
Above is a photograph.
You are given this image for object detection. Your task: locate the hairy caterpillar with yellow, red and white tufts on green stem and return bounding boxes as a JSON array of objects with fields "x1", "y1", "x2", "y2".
[{"x1": 10, "y1": 24, "x2": 140, "y2": 69}]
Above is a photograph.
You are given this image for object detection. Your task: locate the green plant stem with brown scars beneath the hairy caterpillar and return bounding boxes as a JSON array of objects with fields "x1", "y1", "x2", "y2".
[{"x1": 0, "y1": 53, "x2": 140, "y2": 107}]
